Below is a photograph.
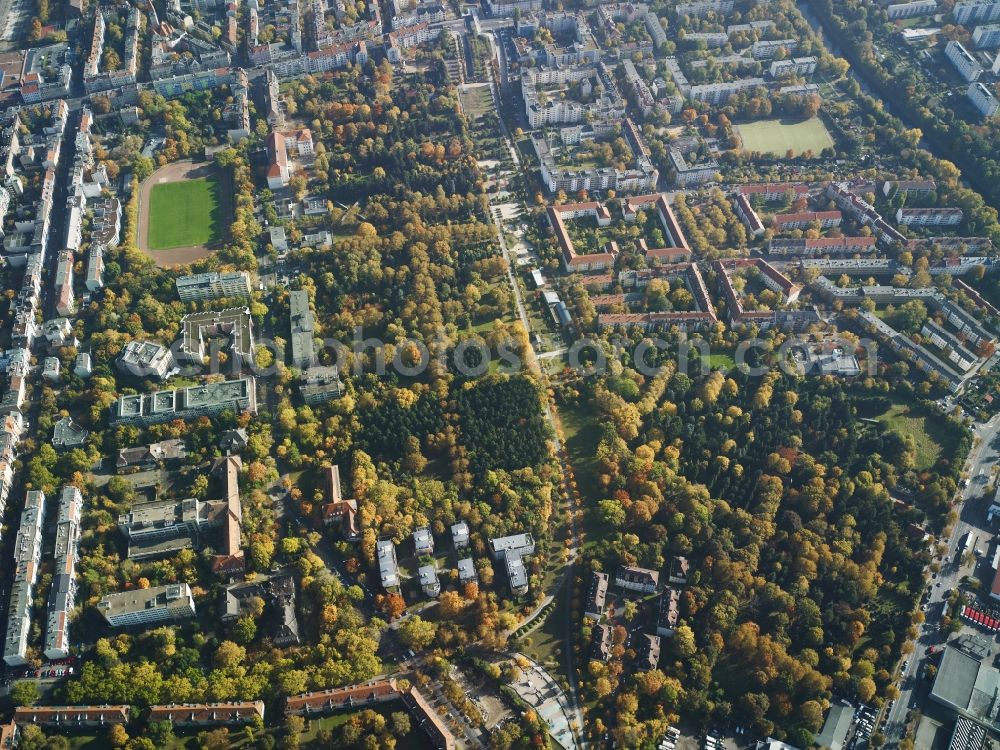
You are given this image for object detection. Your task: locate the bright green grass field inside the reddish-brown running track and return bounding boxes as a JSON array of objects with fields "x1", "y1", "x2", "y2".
[{"x1": 147, "y1": 177, "x2": 222, "y2": 250}]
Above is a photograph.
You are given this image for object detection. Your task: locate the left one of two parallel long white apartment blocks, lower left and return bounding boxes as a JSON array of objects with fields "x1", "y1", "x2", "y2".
[{"x1": 3, "y1": 490, "x2": 45, "y2": 667}]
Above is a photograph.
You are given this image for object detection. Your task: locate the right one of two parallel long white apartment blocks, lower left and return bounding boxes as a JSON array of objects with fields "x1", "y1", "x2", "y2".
[{"x1": 44, "y1": 486, "x2": 83, "y2": 659}]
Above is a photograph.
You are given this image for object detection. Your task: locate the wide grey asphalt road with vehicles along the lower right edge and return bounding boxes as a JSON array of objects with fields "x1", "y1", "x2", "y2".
[{"x1": 883, "y1": 415, "x2": 1000, "y2": 747}]
